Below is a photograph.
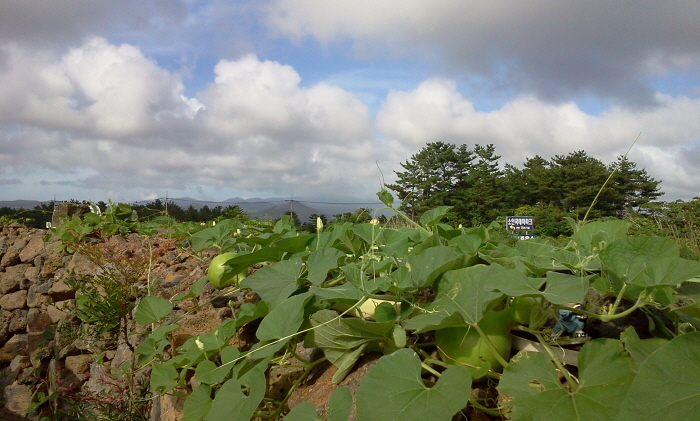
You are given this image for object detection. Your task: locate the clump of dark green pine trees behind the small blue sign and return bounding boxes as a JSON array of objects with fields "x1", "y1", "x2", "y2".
[{"x1": 387, "y1": 142, "x2": 663, "y2": 236}]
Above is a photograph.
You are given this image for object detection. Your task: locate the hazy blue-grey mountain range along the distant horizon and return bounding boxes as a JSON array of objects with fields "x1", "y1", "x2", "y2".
[{"x1": 0, "y1": 197, "x2": 391, "y2": 222}]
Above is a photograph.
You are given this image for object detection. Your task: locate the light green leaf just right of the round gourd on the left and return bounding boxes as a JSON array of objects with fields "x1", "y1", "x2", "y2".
[{"x1": 241, "y1": 257, "x2": 302, "y2": 310}]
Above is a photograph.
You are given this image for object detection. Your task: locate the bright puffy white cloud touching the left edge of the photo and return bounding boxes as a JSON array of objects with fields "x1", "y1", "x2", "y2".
[{"x1": 0, "y1": 38, "x2": 188, "y2": 137}]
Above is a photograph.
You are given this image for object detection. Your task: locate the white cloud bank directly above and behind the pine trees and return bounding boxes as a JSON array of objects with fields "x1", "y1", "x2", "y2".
[{"x1": 377, "y1": 79, "x2": 700, "y2": 198}]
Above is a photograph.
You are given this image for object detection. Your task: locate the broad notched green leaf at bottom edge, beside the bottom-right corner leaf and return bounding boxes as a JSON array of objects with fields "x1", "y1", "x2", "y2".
[{"x1": 498, "y1": 339, "x2": 635, "y2": 421}]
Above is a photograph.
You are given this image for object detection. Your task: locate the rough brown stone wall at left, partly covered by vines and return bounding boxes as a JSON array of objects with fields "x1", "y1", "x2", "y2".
[{"x1": 0, "y1": 224, "x2": 219, "y2": 421}]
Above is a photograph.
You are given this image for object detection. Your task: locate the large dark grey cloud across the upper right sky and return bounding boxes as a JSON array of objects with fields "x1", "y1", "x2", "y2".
[{"x1": 265, "y1": 0, "x2": 700, "y2": 106}]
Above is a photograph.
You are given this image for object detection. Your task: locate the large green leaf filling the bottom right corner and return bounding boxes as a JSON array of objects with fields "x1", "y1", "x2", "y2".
[{"x1": 617, "y1": 332, "x2": 700, "y2": 421}]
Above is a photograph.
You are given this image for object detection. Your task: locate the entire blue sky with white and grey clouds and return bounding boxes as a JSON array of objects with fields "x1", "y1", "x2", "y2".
[{"x1": 0, "y1": 0, "x2": 700, "y2": 202}]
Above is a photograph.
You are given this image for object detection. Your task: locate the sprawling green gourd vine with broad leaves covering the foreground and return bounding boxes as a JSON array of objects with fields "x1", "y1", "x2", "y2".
[{"x1": 46, "y1": 190, "x2": 700, "y2": 421}]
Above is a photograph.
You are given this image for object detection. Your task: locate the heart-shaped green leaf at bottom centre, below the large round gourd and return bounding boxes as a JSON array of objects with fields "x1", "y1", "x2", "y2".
[{"x1": 357, "y1": 349, "x2": 472, "y2": 421}]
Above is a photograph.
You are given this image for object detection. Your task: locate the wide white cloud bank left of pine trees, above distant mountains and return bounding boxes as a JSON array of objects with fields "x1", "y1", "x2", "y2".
[{"x1": 0, "y1": 38, "x2": 377, "y2": 197}]
